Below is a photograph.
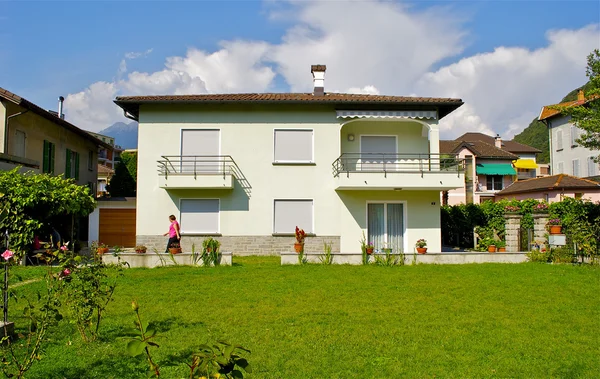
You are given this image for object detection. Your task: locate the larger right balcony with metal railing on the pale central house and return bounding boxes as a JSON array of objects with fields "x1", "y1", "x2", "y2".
[{"x1": 333, "y1": 153, "x2": 465, "y2": 191}]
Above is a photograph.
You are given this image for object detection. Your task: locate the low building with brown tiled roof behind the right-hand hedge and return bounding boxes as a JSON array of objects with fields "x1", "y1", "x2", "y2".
[{"x1": 496, "y1": 174, "x2": 600, "y2": 203}]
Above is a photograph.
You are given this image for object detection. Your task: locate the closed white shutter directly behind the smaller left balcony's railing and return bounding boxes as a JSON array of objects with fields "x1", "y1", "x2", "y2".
[{"x1": 181, "y1": 129, "x2": 222, "y2": 174}]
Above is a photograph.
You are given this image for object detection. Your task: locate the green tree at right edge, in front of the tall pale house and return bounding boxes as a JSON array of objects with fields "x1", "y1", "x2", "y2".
[{"x1": 557, "y1": 49, "x2": 600, "y2": 162}]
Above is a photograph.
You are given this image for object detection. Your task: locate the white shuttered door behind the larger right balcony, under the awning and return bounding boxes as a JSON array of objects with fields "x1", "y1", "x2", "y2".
[{"x1": 360, "y1": 136, "x2": 397, "y2": 171}]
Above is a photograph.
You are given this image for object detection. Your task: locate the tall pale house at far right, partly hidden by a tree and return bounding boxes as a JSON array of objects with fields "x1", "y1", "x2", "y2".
[{"x1": 538, "y1": 90, "x2": 600, "y2": 178}]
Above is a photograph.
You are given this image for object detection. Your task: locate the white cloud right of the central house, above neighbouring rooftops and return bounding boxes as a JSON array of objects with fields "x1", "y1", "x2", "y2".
[{"x1": 415, "y1": 25, "x2": 600, "y2": 138}]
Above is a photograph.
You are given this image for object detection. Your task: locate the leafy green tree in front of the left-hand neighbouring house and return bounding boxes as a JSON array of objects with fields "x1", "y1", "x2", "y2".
[{"x1": 0, "y1": 168, "x2": 96, "y2": 254}]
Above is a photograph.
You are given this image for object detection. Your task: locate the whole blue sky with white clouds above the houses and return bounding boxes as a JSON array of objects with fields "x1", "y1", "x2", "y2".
[{"x1": 0, "y1": 0, "x2": 600, "y2": 139}]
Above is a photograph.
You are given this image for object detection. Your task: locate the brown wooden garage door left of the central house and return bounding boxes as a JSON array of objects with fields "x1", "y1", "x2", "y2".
[{"x1": 98, "y1": 208, "x2": 135, "y2": 247}]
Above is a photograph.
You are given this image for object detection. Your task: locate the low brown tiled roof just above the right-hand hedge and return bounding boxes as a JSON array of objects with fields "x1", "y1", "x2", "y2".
[{"x1": 498, "y1": 174, "x2": 600, "y2": 195}]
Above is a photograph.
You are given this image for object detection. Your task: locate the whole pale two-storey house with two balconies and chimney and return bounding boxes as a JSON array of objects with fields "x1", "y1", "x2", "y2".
[{"x1": 115, "y1": 65, "x2": 464, "y2": 254}]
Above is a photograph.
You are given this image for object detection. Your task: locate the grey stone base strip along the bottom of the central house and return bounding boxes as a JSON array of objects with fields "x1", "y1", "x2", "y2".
[{"x1": 136, "y1": 235, "x2": 340, "y2": 255}]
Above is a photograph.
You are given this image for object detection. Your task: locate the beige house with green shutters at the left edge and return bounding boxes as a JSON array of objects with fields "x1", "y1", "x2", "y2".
[{"x1": 0, "y1": 88, "x2": 109, "y2": 193}]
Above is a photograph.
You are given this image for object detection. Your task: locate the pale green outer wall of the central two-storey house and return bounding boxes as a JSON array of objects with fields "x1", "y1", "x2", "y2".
[{"x1": 136, "y1": 105, "x2": 441, "y2": 254}]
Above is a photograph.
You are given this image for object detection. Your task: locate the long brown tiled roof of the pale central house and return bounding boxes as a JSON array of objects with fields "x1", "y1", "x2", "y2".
[{"x1": 115, "y1": 93, "x2": 463, "y2": 118}]
